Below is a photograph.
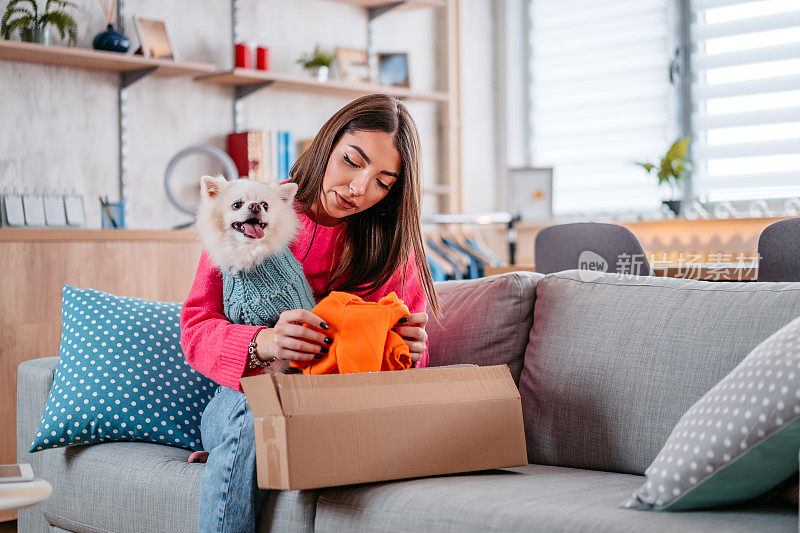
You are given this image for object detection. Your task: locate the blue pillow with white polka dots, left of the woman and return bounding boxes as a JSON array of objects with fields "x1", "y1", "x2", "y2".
[{"x1": 28, "y1": 285, "x2": 216, "y2": 452}]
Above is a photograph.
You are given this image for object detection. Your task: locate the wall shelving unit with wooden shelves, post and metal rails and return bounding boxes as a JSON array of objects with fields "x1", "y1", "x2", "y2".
[{"x1": 0, "y1": 0, "x2": 461, "y2": 213}]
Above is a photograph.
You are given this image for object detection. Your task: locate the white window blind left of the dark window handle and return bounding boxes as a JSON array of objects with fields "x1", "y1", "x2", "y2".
[{"x1": 529, "y1": 0, "x2": 672, "y2": 215}]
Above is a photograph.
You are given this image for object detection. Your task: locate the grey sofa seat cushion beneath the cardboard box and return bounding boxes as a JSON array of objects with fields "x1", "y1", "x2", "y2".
[{"x1": 315, "y1": 465, "x2": 797, "y2": 533}]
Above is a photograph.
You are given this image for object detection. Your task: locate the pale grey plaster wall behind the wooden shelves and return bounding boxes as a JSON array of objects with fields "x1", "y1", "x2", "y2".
[{"x1": 0, "y1": 0, "x2": 444, "y2": 229}]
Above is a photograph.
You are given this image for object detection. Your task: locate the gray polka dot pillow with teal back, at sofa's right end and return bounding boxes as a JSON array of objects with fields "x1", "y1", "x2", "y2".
[{"x1": 620, "y1": 318, "x2": 800, "y2": 511}]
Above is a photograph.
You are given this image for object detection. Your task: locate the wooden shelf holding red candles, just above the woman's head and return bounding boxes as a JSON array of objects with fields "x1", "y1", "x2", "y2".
[{"x1": 195, "y1": 68, "x2": 449, "y2": 102}]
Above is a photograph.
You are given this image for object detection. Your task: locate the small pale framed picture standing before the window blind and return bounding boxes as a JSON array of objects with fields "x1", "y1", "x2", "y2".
[{"x1": 507, "y1": 167, "x2": 553, "y2": 222}]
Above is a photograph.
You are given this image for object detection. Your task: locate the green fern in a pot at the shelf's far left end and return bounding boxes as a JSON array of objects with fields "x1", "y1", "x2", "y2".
[{"x1": 0, "y1": 0, "x2": 78, "y2": 45}]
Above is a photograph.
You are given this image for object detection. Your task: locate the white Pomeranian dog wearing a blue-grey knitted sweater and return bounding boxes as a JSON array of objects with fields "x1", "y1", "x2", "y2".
[{"x1": 197, "y1": 176, "x2": 315, "y2": 327}]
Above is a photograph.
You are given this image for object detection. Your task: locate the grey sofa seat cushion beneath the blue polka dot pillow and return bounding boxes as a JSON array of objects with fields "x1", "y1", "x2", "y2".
[{"x1": 35, "y1": 442, "x2": 203, "y2": 532}]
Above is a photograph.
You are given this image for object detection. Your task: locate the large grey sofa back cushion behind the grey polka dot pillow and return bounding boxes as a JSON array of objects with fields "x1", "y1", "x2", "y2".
[{"x1": 520, "y1": 271, "x2": 800, "y2": 474}]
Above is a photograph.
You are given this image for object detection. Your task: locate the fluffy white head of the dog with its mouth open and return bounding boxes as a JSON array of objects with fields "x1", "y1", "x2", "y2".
[{"x1": 197, "y1": 176, "x2": 297, "y2": 270}]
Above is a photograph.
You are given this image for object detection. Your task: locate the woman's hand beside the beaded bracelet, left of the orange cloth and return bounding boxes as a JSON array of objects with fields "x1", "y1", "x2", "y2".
[{"x1": 256, "y1": 309, "x2": 333, "y2": 361}]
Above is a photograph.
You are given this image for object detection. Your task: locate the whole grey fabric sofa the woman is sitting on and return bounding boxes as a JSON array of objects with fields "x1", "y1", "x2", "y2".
[{"x1": 17, "y1": 271, "x2": 800, "y2": 532}]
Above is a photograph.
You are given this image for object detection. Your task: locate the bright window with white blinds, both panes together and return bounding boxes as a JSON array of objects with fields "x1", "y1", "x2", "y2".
[{"x1": 528, "y1": 0, "x2": 800, "y2": 215}]
